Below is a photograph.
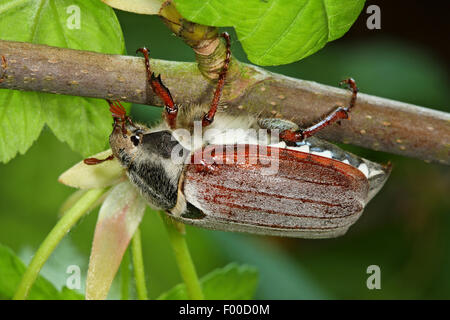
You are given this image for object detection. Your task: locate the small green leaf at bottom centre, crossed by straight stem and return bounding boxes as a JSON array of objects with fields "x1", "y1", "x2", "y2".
[{"x1": 158, "y1": 263, "x2": 258, "y2": 300}]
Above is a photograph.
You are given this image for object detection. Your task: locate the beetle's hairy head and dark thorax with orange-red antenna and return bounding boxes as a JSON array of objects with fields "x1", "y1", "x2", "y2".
[{"x1": 109, "y1": 102, "x2": 189, "y2": 210}]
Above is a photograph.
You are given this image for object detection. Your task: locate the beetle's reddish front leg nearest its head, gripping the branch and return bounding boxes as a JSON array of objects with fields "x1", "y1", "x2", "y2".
[{"x1": 136, "y1": 48, "x2": 178, "y2": 129}]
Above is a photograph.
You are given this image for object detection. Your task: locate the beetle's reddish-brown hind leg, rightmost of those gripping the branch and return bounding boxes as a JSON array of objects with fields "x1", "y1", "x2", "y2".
[{"x1": 280, "y1": 78, "x2": 358, "y2": 142}]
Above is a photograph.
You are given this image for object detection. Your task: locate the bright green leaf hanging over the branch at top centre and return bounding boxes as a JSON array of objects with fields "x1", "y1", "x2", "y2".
[{"x1": 175, "y1": 0, "x2": 364, "y2": 66}]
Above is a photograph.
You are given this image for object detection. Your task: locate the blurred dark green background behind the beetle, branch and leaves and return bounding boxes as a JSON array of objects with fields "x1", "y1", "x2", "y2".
[{"x1": 0, "y1": 1, "x2": 450, "y2": 299}]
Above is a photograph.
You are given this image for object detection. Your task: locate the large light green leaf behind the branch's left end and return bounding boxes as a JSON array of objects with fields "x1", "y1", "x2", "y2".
[{"x1": 0, "y1": 0, "x2": 125, "y2": 162}]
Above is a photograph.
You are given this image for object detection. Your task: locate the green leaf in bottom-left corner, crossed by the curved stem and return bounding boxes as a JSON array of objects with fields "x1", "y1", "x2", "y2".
[{"x1": 0, "y1": 244, "x2": 84, "y2": 300}]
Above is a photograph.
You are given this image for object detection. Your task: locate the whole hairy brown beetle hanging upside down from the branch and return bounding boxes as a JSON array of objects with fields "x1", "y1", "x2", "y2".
[{"x1": 85, "y1": 33, "x2": 391, "y2": 238}]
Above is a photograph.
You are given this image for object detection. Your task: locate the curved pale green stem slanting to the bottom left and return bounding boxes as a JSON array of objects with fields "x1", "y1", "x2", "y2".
[{"x1": 13, "y1": 189, "x2": 106, "y2": 300}]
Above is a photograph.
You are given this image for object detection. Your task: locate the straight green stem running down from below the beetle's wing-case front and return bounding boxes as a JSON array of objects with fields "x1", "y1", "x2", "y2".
[{"x1": 161, "y1": 213, "x2": 205, "y2": 300}]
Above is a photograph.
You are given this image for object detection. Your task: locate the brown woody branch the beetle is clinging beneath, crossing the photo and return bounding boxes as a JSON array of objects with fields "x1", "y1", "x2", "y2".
[{"x1": 0, "y1": 40, "x2": 450, "y2": 164}]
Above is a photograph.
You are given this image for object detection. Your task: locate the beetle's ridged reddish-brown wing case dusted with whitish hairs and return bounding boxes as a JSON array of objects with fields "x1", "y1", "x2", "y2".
[{"x1": 182, "y1": 145, "x2": 369, "y2": 238}]
